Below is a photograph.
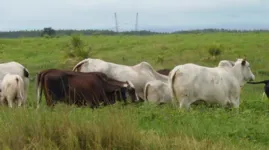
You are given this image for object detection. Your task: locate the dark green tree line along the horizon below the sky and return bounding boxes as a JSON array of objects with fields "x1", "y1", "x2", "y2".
[{"x1": 0, "y1": 27, "x2": 269, "y2": 38}]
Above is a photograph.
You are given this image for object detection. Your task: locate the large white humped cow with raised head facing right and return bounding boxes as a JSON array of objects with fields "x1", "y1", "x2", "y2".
[{"x1": 169, "y1": 59, "x2": 255, "y2": 110}]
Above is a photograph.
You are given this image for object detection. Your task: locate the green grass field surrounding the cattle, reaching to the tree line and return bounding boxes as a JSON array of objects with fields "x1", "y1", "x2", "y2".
[{"x1": 0, "y1": 32, "x2": 269, "y2": 150}]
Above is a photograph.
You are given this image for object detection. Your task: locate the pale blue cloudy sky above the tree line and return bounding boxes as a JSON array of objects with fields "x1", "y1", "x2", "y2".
[{"x1": 0, "y1": 0, "x2": 269, "y2": 31}]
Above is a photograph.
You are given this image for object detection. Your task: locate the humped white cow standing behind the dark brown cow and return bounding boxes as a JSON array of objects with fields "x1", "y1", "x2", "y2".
[{"x1": 73, "y1": 58, "x2": 168, "y2": 99}]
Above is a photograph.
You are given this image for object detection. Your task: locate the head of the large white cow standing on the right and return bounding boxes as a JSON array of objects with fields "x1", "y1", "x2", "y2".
[{"x1": 235, "y1": 59, "x2": 255, "y2": 84}]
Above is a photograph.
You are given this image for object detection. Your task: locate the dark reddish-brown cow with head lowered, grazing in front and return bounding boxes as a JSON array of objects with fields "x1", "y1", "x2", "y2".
[{"x1": 36, "y1": 69, "x2": 136, "y2": 108}]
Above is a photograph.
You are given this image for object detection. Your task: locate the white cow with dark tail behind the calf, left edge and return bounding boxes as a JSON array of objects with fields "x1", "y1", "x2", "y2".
[{"x1": 0, "y1": 61, "x2": 29, "y2": 103}]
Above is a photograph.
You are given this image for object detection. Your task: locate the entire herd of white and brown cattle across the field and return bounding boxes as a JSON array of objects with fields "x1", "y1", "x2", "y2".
[{"x1": 0, "y1": 58, "x2": 269, "y2": 109}]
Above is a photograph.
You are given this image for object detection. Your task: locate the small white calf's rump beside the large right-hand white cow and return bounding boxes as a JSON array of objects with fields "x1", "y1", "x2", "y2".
[{"x1": 144, "y1": 80, "x2": 172, "y2": 104}]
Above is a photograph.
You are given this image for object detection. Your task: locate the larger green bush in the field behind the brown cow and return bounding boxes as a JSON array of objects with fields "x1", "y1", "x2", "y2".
[{"x1": 65, "y1": 34, "x2": 92, "y2": 59}]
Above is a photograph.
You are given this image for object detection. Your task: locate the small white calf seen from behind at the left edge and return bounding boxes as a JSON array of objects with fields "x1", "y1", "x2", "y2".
[{"x1": 0, "y1": 73, "x2": 26, "y2": 108}]
